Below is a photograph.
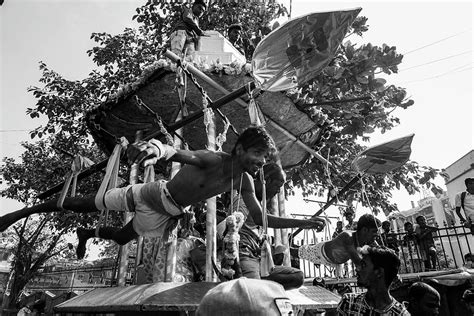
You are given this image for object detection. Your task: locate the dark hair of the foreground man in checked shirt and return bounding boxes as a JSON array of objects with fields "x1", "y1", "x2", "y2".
[{"x1": 359, "y1": 246, "x2": 400, "y2": 287}]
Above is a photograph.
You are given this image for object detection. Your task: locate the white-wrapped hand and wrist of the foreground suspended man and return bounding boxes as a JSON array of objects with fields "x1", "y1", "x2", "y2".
[{"x1": 127, "y1": 139, "x2": 176, "y2": 167}]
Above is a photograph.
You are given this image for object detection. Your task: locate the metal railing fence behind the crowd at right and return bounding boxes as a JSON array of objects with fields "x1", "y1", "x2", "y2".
[{"x1": 298, "y1": 223, "x2": 474, "y2": 279}]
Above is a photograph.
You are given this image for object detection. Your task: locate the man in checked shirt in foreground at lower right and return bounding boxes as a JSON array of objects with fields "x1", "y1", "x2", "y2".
[{"x1": 337, "y1": 247, "x2": 410, "y2": 316}]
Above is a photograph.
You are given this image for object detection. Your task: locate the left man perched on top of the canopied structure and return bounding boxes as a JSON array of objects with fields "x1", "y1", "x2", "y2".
[{"x1": 170, "y1": 0, "x2": 206, "y2": 57}]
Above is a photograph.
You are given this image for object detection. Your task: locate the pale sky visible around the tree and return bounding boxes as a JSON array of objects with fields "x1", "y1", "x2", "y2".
[{"x1": 0, "y1": 0, "x2": 474, "y2": 227}]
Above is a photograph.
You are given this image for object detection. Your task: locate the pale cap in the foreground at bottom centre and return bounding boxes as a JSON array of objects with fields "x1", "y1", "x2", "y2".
[{"x1": 196, "y1": 277, "x2": 293, "y2": 316}]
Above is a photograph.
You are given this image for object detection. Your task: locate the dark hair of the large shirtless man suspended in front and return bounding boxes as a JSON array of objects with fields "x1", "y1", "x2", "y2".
[{"x1": 232, "y1": 126, "x2": 276, "y2": 158}]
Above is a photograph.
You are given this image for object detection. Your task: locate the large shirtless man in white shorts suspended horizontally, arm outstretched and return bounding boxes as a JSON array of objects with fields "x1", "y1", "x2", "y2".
[{"x1": 0, "y1": 127, "x2": 324, "y2": 258}]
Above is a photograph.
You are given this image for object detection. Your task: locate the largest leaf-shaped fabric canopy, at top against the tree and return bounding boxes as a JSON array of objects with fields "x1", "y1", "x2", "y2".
[{"x1": 252, "y1": 8, "x2": 362, "y2": 91}]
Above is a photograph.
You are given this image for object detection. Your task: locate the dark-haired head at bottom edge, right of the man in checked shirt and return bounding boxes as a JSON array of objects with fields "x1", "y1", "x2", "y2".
[{"x1": 407, "y1": 282, "x2": 441, "y2": 316}]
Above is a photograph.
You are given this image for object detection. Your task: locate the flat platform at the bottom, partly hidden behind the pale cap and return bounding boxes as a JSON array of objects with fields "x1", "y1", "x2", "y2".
[{"x1": 55, "y1": 282, "x2": 340, "y2": 315}]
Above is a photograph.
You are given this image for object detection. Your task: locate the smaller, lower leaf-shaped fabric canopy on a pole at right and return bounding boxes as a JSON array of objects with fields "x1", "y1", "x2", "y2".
[{"x1": 351, "y1": 134, "x2": 415, "y2": 174}]
